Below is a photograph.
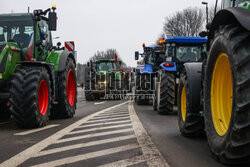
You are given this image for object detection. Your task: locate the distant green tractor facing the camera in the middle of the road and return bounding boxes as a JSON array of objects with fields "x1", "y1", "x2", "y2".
[{"x1": 85, "y1": 59, "x2": 129, "y2": 101}]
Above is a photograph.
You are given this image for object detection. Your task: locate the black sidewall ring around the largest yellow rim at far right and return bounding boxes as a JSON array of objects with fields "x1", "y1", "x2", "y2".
[{"x1": 204, "y1": 35, "x2": 236, "y2": 155}]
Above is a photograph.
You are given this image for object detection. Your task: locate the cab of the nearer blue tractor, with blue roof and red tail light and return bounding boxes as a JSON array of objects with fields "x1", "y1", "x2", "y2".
[{"x1": 161, "y1": 37, "x2": 207, "y2": 71}]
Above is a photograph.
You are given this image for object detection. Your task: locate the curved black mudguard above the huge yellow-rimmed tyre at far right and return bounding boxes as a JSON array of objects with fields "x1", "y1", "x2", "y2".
[{"x1": 208, "y1": 7, "x2": 250, "y2": 48}]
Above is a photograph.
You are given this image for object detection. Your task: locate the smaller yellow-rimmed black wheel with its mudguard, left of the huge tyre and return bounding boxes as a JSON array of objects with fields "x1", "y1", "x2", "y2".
[{"x1": 177, "y1": 66, "x2": 204, "y2": 137}]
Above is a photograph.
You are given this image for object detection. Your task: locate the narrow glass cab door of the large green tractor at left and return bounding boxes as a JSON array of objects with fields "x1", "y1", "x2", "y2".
[{"x1": 36, "y1": 20, "x2": 52, "y2": 61}]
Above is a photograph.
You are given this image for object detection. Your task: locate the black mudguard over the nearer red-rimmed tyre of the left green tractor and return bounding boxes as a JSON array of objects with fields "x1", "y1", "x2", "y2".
[{"x1": 17, "y1": 61, "x2": 56, "y2": 101}]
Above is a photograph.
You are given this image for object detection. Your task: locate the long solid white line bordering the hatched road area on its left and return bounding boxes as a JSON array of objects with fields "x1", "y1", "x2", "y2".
[{"x1": 0, "y1": 101, "x2": 128, "y2": 167}]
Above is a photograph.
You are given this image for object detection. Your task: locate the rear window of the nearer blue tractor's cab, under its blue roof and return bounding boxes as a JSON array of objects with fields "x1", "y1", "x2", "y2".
[{"x1": 176, "y1": 46, "x2": 201, "y2": 62}]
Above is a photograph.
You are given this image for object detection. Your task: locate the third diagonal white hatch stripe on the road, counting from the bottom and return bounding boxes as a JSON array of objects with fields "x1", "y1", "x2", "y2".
[{"x1": 34, "y1": 135, "x2": 135, "y2": 157}]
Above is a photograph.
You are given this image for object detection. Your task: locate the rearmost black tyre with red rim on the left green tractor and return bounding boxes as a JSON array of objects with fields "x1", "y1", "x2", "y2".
[{"x1": 51, "y1": 58, "x2": 77, "y2": 118}]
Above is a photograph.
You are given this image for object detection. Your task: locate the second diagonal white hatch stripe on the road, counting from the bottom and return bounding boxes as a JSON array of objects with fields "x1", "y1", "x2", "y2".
[{"x1": 33, "y1": 144, "x2": 139, "y2": 167}]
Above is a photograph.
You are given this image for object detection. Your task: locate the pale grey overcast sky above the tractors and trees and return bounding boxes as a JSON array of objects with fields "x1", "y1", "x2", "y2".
[{"x1": 0, "y1": 0, "x2": 215, "y2": 66}]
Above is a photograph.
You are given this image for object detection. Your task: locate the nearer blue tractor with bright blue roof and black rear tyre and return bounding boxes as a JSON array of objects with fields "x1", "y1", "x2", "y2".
[{"x1": 153, "y1": 37, "x2": 207, "y2": 114}]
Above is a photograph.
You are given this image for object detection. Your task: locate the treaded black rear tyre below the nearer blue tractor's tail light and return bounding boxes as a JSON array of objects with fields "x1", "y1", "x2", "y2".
[{"x1": 156, "y1": 72, "x2": 175, "y2": 114}]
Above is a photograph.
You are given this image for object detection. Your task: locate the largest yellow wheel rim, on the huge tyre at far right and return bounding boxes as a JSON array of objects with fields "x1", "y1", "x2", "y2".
[{"x1": 211, "y1": 53, "x2": 233, "y2": 136}]
